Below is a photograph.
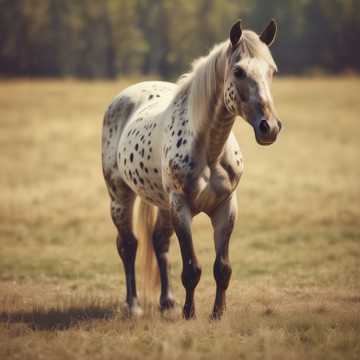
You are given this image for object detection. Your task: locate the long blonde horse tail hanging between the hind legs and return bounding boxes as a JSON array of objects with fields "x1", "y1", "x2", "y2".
[{"x1": 134, "y1": 198, "x2": 160, "y2": 304}]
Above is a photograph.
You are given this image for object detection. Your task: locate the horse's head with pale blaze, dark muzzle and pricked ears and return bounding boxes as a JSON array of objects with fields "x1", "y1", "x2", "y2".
[{"x1": 224, "y1": 20, "x2": 281, "y2": 145}]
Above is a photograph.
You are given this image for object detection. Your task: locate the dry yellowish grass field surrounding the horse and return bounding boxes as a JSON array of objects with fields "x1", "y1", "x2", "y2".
[{"x1": 0, "y1": 78, "x2": 360, "y2": 360}]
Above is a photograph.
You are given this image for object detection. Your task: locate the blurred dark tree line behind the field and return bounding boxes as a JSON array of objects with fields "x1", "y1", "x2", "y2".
[{"x1": 0, "y1": 0, "x2": 360, "y2": 78}]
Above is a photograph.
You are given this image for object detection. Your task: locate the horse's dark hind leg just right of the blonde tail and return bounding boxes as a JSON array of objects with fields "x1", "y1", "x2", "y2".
[{"x1": 152, "y1": 209, "x2": 175, "y2": 311}]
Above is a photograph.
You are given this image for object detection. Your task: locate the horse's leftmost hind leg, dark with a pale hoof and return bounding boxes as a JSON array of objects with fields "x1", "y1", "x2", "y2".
[{"x1": 111, "y1": 185, "x2": 142, "y2": 316}]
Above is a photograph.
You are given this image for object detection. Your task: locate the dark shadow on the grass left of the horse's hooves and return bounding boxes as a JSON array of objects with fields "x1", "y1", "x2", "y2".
[{"x1": 0, "y1": 303, "x2": 120, "y2": 331}]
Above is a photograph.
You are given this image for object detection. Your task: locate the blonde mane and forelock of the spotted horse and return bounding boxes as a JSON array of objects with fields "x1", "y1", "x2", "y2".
[{"x1": 175, "y1": 30, "x2": 277, "y2": 131}]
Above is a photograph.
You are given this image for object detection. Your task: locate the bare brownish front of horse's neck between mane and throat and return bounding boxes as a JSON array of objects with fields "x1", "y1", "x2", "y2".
[{"x1": 205, "y1": 89, "x2": 235, "y2": 164}]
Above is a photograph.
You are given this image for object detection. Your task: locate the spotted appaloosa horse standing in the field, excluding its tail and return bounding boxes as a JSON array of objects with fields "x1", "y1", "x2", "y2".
[{"x1": 102, "y1": 20, "x2": 281, "y2": 319}]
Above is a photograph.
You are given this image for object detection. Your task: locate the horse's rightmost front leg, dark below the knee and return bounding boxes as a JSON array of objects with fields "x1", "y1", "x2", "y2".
[{"x1": 210, "y1": 193, "x2": 237, "y2": 319}]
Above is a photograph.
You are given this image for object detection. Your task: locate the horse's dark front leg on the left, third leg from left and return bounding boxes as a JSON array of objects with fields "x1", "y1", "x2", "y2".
[{"x1": 170, "y1": 193, "x2": 201, "y2": 319}]
